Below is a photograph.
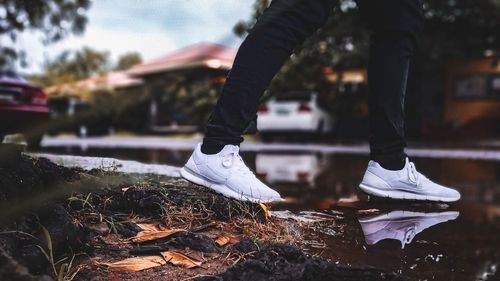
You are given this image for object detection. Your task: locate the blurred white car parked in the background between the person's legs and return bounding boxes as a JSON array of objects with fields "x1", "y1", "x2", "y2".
[{"x1": 257, "y1": 92, "x2": 333, "y2": 136}]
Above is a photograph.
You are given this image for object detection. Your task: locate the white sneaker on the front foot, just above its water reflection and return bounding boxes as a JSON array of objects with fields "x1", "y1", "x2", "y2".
[{"x1": 359, "y1": 158, "x2": 460, "y2": 202}]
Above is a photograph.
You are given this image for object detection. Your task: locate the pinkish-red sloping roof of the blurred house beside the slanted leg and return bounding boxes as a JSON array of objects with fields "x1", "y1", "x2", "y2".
[{"x1": 128, "y1": 42, "x2": 236, "y2": 76}]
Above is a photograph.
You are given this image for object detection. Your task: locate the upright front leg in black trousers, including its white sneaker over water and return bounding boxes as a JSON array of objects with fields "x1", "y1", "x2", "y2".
[{"x1": 358, "y1": 0, "x2": 460, "y2": 202}]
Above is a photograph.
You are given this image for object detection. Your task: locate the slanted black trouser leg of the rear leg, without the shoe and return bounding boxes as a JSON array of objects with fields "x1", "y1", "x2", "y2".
[{"x1": 202, "y1": 0, "x2": 336, "y2": 154}]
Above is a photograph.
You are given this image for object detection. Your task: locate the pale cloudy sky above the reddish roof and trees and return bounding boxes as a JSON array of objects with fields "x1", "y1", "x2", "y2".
[{"x1": 16, "y1": 0, "x2": 254, "y2": 73}]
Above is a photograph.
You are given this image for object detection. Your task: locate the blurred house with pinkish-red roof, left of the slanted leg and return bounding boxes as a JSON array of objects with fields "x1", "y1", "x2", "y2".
[{"x1": 42, "y1": 42, "x2": 236, "y2": 133}]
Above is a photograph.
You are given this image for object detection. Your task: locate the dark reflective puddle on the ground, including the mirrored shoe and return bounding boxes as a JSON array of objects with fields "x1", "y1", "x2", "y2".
[{"x1": 41, "y1": 143, "x2": 500, "y2": 280}]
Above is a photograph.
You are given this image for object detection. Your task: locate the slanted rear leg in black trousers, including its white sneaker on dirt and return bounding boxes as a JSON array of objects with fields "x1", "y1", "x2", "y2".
[{"x1": 184, "y1": 0, "x2": 335, "y2": 202}]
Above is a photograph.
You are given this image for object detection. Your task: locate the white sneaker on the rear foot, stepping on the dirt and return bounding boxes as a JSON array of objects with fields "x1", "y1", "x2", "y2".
[{"x1": 181, "y1": 144, "x2": 283, "y2": 203}]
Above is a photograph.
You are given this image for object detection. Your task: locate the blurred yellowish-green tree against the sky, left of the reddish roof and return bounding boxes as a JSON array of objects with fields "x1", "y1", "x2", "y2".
[{"x1": 31, "y1": 47, "x2": 110, "y2": 87}]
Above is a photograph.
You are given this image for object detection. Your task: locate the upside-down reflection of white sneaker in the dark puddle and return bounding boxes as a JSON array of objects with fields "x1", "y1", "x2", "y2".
[{"x1": 358, "y1": 211, "x2": 459, "y2": 249}]
